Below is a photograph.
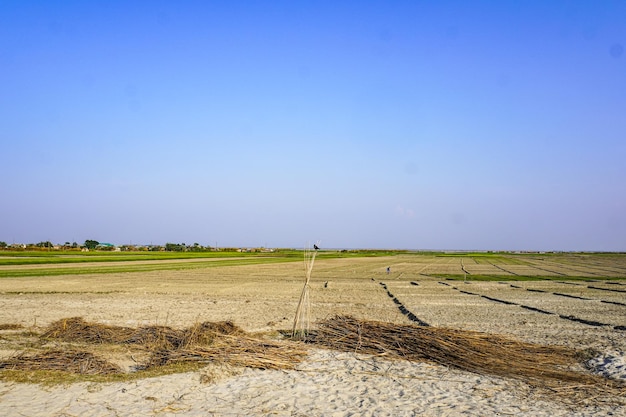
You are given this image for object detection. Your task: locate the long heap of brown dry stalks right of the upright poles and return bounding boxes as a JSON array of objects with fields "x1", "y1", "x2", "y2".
[{"x1": 312, "y1": 316, "x2": 626, "y2": 397}]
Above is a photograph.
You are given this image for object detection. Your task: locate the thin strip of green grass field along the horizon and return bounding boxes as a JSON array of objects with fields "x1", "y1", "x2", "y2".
[{"x1": 0, "y1": 249, "x2": 626, "y2": 281}]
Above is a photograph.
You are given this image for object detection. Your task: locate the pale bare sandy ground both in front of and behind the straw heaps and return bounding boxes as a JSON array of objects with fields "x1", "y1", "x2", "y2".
[{"x1": 0, "y1": 257, "x2": 626, "y2": 416}]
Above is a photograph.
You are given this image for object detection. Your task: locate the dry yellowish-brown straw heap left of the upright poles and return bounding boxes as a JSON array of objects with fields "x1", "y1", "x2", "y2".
[{"x1": 0, "y1": 317, "x2": 306, "y2": 374}]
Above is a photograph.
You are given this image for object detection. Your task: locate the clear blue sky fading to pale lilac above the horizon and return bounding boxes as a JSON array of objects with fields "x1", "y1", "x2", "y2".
[{"x1": 0, "y1": 0, "x2": 626, "y2": 251}]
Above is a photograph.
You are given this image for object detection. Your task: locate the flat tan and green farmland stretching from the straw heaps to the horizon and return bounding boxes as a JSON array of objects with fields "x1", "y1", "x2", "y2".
[{"x1": 0, "y1": 254, "x2": 626, "y2": 345}]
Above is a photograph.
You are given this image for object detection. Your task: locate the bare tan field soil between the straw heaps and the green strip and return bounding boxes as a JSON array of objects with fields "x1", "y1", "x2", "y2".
[{"x1": 0, "y1": 255, "x2": 626, "y2": 351}]
